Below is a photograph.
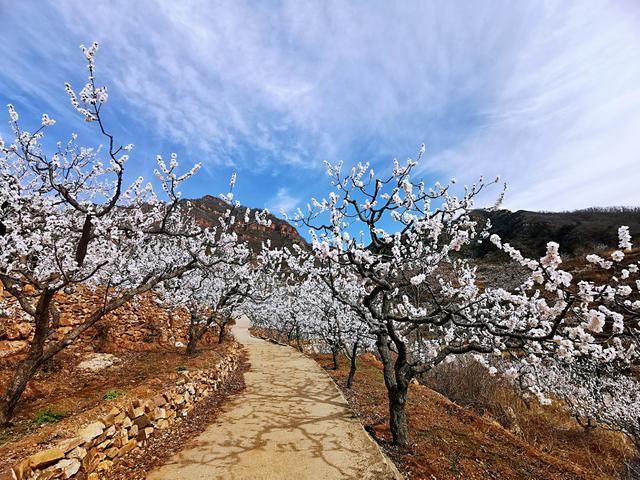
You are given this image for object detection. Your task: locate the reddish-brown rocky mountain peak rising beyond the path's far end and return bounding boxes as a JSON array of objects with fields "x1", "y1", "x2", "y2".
[{"x1": 184, "y1": 195, "x2": 306, "y2": 251}]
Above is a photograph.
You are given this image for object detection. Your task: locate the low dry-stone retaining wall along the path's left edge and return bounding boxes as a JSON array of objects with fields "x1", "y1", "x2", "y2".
[{"x1": 13, "y1": 344, "x2": 241, "y2": 480}]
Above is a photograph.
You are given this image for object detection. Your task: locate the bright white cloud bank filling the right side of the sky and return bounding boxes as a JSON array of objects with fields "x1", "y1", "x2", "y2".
[{"x1": 427, "y1": 2, "x2": 640, "y2": 210}]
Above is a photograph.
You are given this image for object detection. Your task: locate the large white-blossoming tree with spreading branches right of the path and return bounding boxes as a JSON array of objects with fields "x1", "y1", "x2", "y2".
[{"x1": 293, "y1": 146, "x2": 639, "y2": 446}]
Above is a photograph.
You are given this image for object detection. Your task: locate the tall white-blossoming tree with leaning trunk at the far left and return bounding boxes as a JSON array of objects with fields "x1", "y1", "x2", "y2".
[{"x1": 0, "y1": 43, "x2": 208, "y2": 424}]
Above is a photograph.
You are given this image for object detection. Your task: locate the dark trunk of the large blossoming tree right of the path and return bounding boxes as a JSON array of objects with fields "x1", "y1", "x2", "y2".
[{"x1": 376, "y1": 333, "x2": 411, "y2": 447}]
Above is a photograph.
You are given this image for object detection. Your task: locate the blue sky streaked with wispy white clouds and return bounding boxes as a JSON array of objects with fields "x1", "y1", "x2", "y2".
[{"x1": 0, "y1": 0, "x2": 640, "y2": 219}]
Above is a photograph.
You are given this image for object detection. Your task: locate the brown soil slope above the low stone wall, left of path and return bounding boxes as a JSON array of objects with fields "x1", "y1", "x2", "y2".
[{"x1": 0, "y1": 339, "x2": 238, "y2": 473}]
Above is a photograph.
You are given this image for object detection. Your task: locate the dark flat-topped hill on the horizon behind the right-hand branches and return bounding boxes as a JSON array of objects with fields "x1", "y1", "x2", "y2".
[{"x1": 474, "y1": 208, "x2": 640, "y2": 258}]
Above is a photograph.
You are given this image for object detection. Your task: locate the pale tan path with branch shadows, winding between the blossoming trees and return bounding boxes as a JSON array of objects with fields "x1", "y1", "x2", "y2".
[{"x1": 147, "y1": 320, "x2": 398, "y2": 480}]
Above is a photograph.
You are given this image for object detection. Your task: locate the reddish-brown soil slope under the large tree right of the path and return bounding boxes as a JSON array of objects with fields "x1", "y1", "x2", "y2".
[{"x1": 315, "y1": 355, "x2": 633, "y2": 480}]
